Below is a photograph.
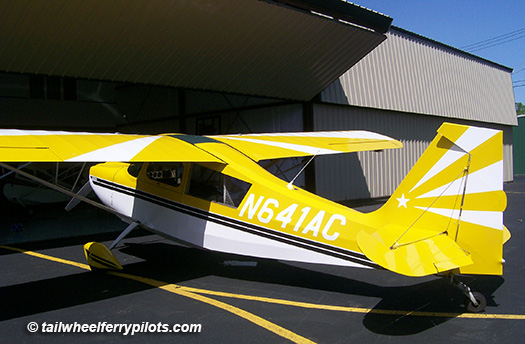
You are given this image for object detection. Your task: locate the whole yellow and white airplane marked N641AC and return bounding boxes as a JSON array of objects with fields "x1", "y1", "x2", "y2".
[{"x1": 0, "y1": 123, "x2": 510, "y2": 312}]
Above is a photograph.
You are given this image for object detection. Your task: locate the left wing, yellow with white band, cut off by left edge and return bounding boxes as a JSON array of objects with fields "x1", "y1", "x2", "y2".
[{"x1": 0, "y1": 129, "x2": 224, "y2": 163}]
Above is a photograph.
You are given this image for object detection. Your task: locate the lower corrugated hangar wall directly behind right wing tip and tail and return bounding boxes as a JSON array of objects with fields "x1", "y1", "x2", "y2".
[{"x1": 314, "y1": 105, "x2": 513, "y2": 201}]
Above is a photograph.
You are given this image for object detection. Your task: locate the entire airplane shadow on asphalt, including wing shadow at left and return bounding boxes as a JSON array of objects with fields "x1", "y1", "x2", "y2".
[{"x1": 0, "y1": 236, "x2": 504, "y2": 336}]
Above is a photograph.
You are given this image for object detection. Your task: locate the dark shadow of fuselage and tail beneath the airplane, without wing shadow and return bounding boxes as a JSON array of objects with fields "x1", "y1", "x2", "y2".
[{"x1": 119, "y1": 243, "x2": 504, "y2": 335}]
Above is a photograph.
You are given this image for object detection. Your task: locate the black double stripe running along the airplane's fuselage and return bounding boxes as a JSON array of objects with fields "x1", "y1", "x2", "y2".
[{"x1": 92, "y1": 178, "x2": 376, "y2": 269}]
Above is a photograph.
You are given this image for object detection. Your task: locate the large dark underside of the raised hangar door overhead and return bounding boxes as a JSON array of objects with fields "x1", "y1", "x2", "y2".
[{"x1": 0, "y1": 0, "x2": 385, "y2": 100}]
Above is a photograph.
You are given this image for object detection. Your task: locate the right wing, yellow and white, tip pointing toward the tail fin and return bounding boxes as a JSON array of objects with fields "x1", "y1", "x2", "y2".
[{"x1": 210, "y1": 130, "x2": 403, "y2": 161}]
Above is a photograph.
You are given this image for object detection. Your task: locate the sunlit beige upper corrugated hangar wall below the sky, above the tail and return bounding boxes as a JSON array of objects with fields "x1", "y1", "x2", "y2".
[{"x1": 322, "y1": 29, "x2": 517, "y2": 125}]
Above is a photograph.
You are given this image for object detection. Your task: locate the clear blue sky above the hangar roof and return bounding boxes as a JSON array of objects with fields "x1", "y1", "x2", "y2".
[{"x1": 353, "y1": 0, "x2": 525, "y2": 104}]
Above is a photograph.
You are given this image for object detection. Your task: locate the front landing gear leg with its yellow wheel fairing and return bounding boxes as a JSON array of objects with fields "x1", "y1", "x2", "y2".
[{"x1": 84, "y1": 222, "x2": 138, "y2": 271}]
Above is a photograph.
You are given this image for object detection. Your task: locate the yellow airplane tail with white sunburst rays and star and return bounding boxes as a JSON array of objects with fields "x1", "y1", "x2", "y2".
[{"x1": 357, "y1": 123, "x2": 510, "y2": 276}]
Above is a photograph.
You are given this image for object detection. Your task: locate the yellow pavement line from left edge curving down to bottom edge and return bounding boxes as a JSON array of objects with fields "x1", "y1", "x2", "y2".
[{"x1": 0, "y1": 246, "x2": 315, "y2": 344}]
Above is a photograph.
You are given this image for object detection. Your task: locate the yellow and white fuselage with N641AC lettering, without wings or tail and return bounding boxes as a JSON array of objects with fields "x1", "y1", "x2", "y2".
[{"x1": 90, "y1": 142, "x2": 381, "y2": 267}]
